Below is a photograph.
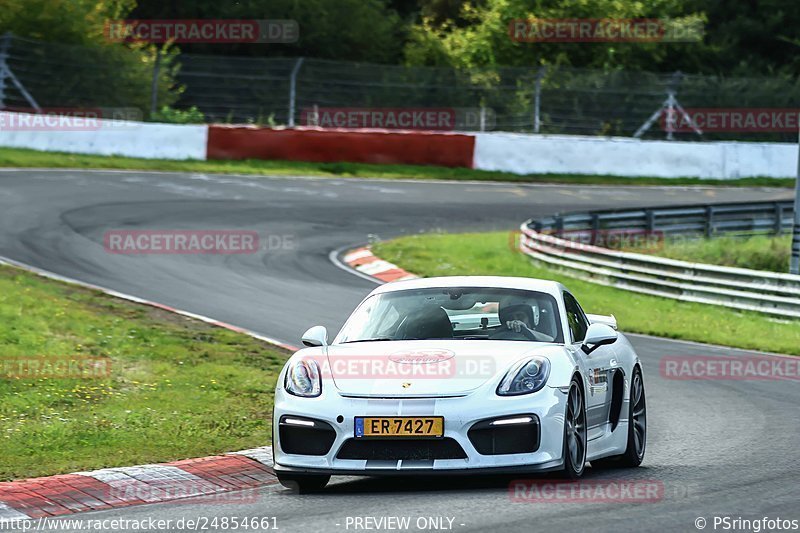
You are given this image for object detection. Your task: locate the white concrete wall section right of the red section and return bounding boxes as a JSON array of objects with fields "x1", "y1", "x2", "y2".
[{"x1": 474, "y1": 133, "x2": 798, "y2": 179}]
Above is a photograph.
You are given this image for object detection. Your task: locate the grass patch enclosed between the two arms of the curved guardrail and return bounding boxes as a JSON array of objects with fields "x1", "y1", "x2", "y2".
[{"x1": 628, "y1": 235, "x2": 792, "y2": 273}]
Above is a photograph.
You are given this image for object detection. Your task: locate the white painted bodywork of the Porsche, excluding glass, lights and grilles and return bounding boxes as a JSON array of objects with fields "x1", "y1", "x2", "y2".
[{"x1": 273, "y1": 276, "x2": 640, "y2": 475}]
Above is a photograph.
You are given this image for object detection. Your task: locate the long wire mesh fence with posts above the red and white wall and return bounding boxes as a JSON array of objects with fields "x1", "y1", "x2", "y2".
[{"x1": 0, "y1": 34, "x2": 800, "y2": 141}]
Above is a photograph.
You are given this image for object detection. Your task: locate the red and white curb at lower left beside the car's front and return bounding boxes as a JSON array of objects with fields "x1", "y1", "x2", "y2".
[{"x1": 0, "y1": 446, "x2": 278, "y2": 521}]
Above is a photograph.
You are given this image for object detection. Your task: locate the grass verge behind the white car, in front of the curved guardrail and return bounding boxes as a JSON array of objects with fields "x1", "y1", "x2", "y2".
[{"x1": 373, "y1": 233, "x2": 800, "y2": 355}]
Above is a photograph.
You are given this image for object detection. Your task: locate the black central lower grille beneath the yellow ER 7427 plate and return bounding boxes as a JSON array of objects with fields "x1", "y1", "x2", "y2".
[{"x1": 336, "y1": 437, "x2": 467, "y2": 461}]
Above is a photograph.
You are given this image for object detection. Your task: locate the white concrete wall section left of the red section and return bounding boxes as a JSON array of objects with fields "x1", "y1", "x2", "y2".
[{"x1": 0, "y1": 112, "x2": 208, "y2": 159}]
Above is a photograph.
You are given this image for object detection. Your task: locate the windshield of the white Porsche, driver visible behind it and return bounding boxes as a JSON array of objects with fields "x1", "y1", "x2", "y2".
[{"x1": 336, "y1": 287, "x2": 563, "y2": 343}]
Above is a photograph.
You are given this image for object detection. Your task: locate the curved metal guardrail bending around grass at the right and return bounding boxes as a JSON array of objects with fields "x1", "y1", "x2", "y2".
[{"x1": 519, "y1": 202, "x2": 800, "y2": 318}]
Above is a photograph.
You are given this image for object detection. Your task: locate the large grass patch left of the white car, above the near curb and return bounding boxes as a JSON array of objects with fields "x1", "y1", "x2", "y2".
[{"x1": 0, "y1": 267, "x2": 287, "y2": 480}]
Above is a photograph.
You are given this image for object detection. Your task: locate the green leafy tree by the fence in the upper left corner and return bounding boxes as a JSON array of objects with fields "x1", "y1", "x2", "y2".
[{"x1": 0, "y1": 0, "x2": 181, "y2": 115}]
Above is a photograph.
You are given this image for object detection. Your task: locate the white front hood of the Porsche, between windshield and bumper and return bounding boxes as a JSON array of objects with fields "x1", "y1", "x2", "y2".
[{"x1": 323, "y1": 340, "x2": 558, "y2": 397}]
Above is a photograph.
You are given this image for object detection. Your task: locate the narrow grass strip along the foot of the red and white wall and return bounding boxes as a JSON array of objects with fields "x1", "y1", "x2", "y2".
[{"x1": 0, "y1": 148, "x2": 794, "y2": 187}]
